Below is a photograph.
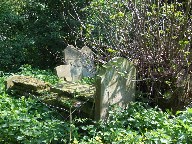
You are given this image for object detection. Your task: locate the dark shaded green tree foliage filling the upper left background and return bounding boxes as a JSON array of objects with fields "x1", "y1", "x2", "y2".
[{"x1": 0, "y1": 0, "x2": 86, "y2": 71}]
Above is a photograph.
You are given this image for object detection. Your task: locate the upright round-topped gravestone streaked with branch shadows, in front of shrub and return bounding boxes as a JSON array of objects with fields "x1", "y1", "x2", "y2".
[{"x1": 95, "y1": 57, "x2": 136, "y2": 120}]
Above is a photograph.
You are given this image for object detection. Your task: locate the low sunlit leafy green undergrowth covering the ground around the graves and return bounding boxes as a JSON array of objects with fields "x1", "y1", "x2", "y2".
[{"x1": 0, "y1": 66, "x2": 192, "y2": 144}]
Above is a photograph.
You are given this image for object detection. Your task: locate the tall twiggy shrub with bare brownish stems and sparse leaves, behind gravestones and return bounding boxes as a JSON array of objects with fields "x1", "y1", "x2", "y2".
[{"x1": 81, "y1": 0, "x2": 192, "y2": 109}]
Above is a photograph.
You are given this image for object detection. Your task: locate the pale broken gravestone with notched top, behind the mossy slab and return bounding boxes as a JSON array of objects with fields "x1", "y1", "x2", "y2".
[{"x1": 55, "y1": 45, "x2": 94, "y2": 82}]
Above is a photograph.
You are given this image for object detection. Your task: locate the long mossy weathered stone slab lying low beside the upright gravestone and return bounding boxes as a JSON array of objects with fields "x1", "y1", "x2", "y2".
[{"x1": 6, "y1": 75, "x2": 96, "y2": 118}]
